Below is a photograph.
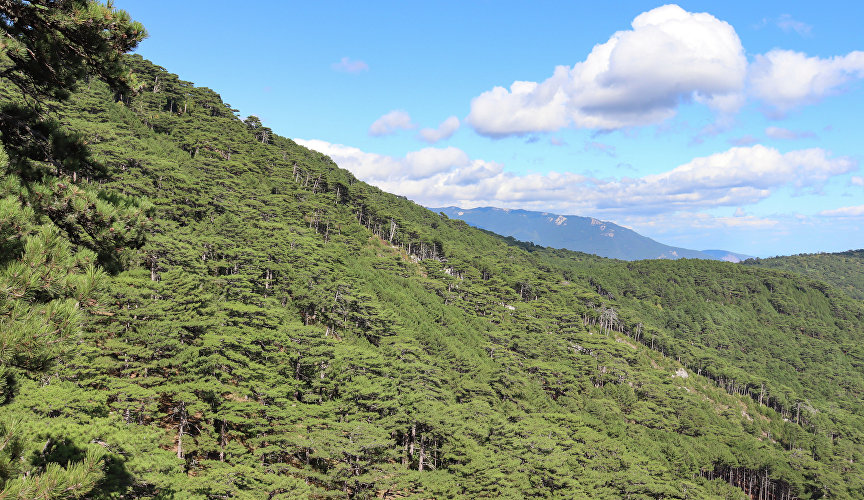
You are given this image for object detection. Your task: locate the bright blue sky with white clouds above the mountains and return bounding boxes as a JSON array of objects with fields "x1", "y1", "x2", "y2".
[{"x1": 115, "y1": 0, "x2": 864, "y2": 256}]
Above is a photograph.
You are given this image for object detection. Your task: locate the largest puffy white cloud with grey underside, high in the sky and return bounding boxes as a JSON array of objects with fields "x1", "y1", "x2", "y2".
[{"x1": 467, "y1": 5, "x2": 747, "y2": 137}]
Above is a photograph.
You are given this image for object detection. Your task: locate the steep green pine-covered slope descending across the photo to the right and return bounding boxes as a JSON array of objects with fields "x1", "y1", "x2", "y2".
[{"x1": 2, "y1": 36, "x2": 864, "y2": 499}]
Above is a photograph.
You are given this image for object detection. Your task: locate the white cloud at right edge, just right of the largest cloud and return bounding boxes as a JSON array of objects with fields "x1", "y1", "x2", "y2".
[{"x1": 749, "y1": 49, "x2": 864, "y2": 113}]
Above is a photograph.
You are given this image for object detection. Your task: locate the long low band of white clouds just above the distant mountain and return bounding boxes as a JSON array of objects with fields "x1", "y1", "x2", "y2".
[{"x1": 295, "y1": 139, "x2": 857, "y2": 219}]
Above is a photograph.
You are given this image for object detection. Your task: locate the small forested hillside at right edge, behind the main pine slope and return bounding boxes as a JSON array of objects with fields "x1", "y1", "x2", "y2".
[{"x1": 743, "y1": 249, "x2": 864, "y2": 300}]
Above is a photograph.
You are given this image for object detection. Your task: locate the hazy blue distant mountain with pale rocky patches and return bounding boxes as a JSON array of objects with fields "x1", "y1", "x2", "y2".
[{"x1": 431, "y1": 207, "x2": 748, "y2": 262}]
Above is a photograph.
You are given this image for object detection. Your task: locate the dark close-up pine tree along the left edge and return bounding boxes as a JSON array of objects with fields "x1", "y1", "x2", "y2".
[{"x1": 0, "y1": 0, "x2": 147, "y2": 498}]
